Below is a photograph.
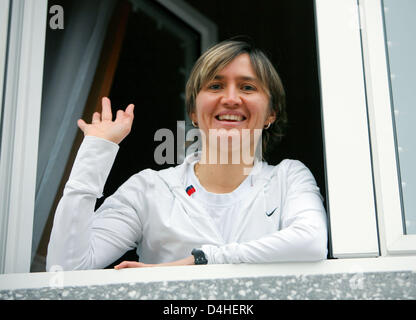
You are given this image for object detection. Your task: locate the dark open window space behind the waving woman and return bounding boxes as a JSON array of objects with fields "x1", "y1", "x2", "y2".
[{"x1": 31, "y1": 0, "x2": 326, "y2": 271}]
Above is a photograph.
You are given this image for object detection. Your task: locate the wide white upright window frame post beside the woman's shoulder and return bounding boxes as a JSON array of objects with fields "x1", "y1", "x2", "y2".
[{"x1": 315, "y1": 0, "x2": 379, "y2": 258}]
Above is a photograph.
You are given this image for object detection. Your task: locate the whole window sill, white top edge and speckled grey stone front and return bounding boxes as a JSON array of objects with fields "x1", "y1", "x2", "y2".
[{"x1": 0, "y1": 256, "x2": 416, "y2": 299}]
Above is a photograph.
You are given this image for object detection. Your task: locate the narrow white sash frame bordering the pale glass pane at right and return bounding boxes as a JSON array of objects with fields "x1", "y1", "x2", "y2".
[{"x1": 360, "y1": 0, "x2": 416, "y2": 255}]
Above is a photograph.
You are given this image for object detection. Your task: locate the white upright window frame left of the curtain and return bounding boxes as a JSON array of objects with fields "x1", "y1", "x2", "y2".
[{"x1": 0, "y1": 0, "x2": 47, "y2": 273}]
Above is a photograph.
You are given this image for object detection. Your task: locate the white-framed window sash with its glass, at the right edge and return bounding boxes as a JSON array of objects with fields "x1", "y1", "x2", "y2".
[{"x1": 360, "y1": 0, "x2": 416, "y2": 255}]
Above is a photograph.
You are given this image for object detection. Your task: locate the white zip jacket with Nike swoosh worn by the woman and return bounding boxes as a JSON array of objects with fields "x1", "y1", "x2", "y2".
[{"x1": 46, "y1": 136, "x2": 327, "y2": 270}]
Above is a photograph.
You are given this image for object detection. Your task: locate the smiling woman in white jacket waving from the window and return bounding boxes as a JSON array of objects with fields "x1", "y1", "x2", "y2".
[{"x1": 47, "y1": 40, "x2": 327, "y2": 270}]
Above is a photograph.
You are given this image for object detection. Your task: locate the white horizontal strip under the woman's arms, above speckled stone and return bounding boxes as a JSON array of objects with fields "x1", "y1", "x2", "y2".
[{"x1": 0, "y1": 256, "x2": 416, "y2": 291}]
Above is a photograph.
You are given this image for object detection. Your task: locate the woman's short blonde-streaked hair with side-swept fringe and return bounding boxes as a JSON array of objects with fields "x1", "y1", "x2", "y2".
[{"x1": 185, "y1": 39, "x2": 287, "y2": 157}]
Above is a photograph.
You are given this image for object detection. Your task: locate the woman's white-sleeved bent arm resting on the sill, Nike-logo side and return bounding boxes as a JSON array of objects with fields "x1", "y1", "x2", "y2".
[{"x1": 201, "y1": 160, "x2": 328, "y2": 264}]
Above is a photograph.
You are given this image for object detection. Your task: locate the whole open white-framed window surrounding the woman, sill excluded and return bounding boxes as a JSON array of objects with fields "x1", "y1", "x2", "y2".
[{"x1": 0, "y1": 0, "x2": 416, "y2": 273}]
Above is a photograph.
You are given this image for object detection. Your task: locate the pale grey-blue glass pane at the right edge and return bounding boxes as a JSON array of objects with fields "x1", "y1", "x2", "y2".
[{"x1": 383, "y1": 0, "x2": 416, "y2": 234}]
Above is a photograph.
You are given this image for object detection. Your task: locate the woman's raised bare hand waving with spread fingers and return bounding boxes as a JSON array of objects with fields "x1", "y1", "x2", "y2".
[{"x1": 77, "y1": 97, "x2": 134, "y2": 144}]
